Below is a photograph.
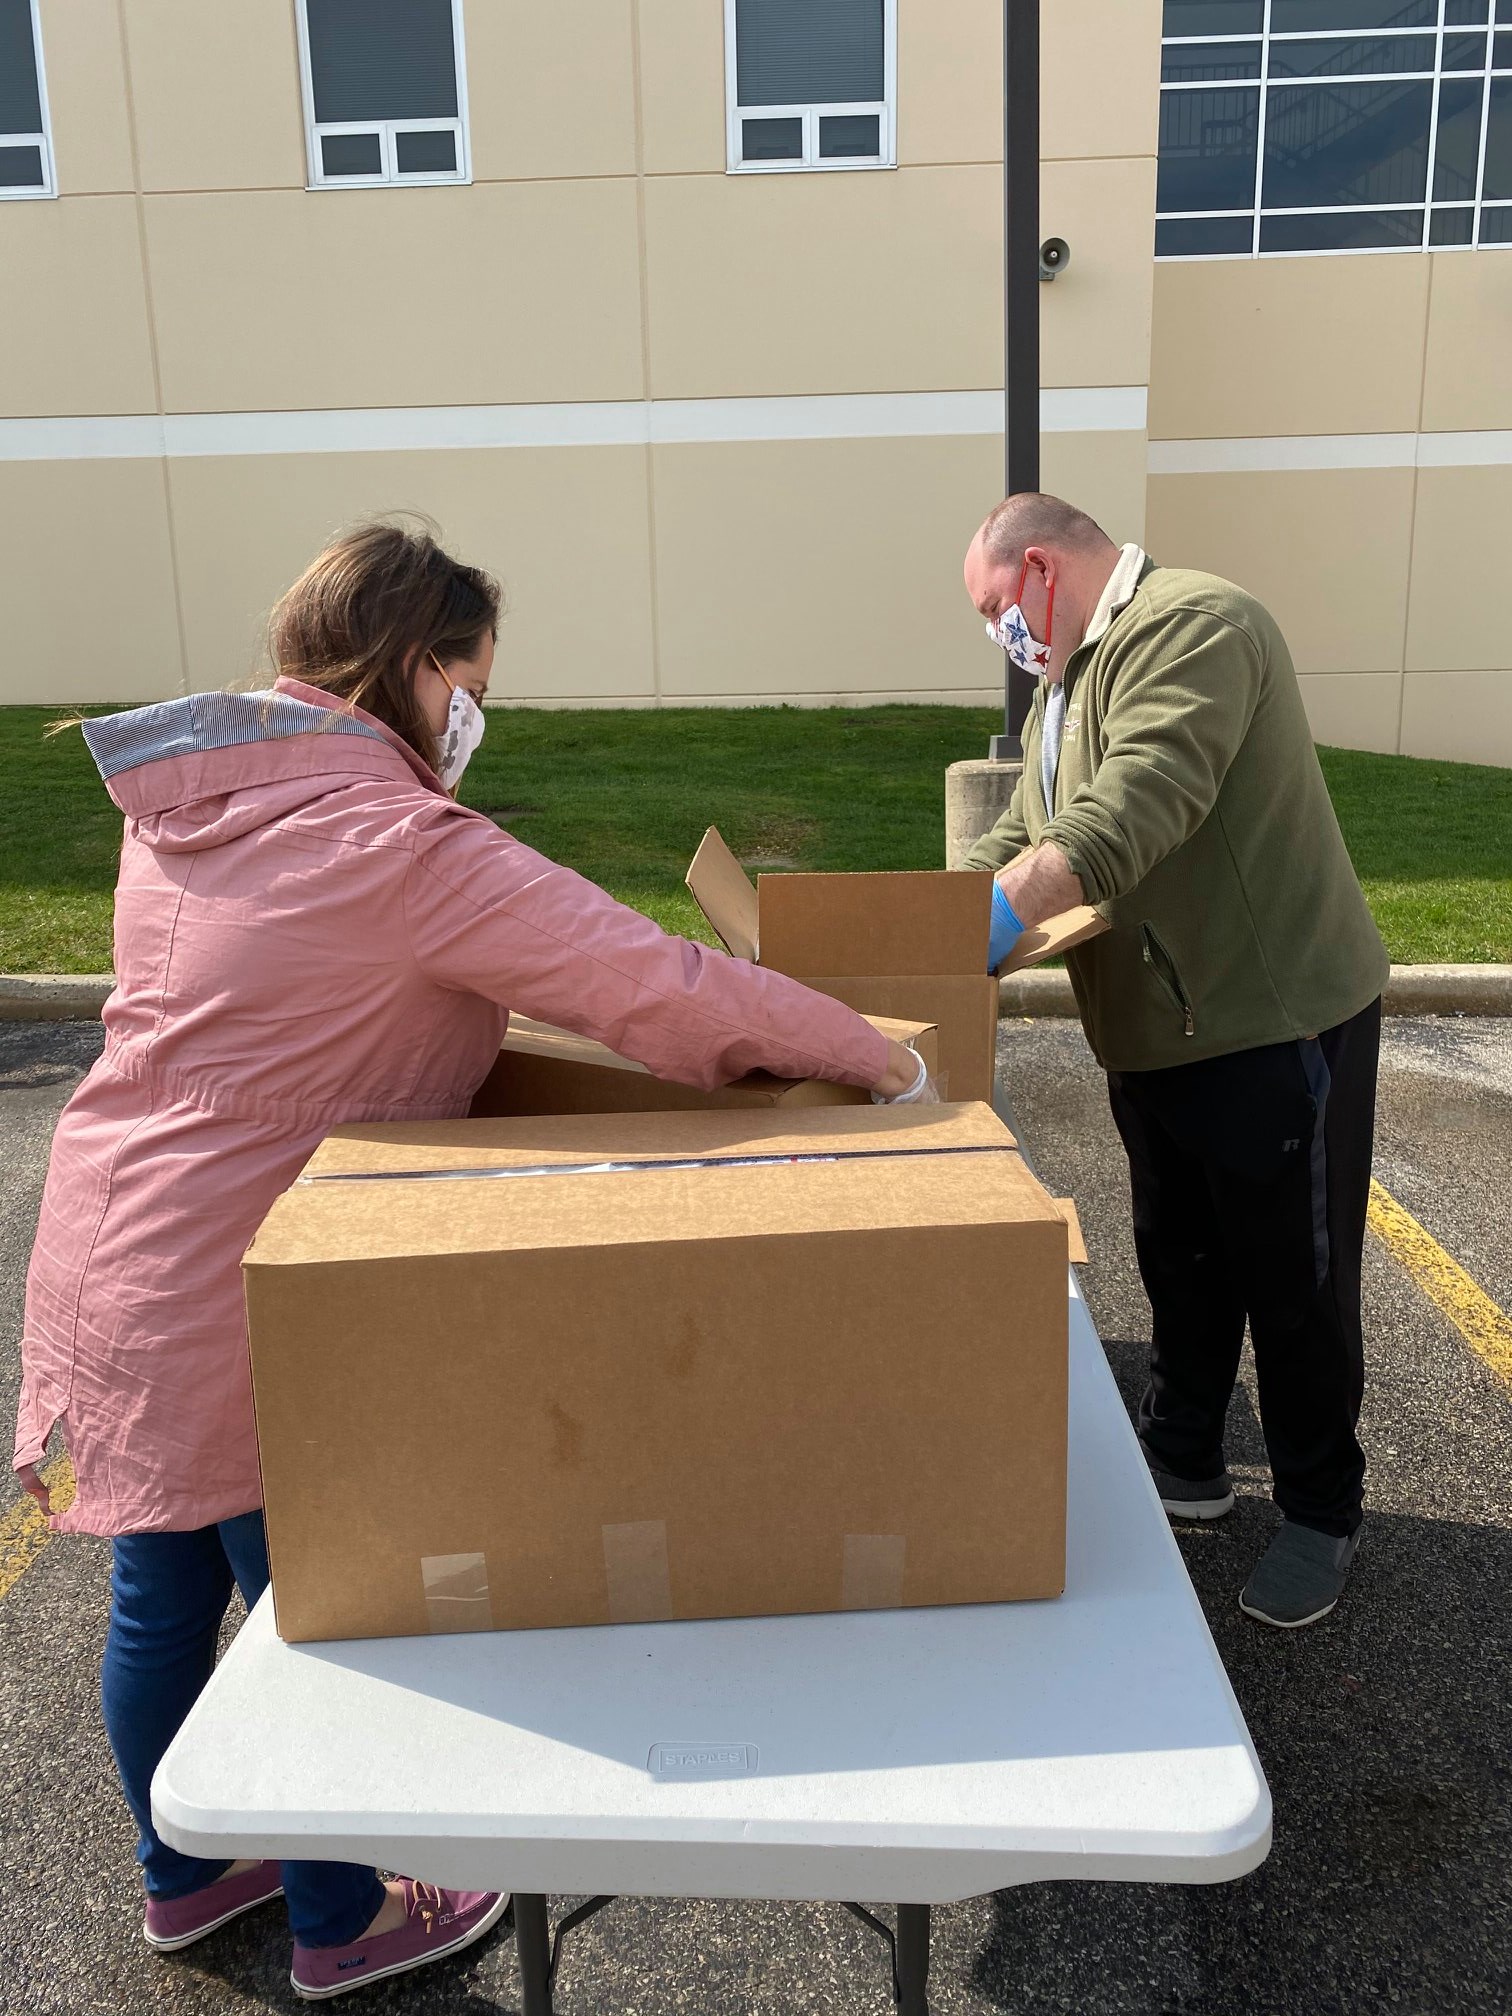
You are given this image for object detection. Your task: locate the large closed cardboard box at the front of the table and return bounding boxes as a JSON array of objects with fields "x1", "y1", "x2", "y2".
[{"x1": 246, "y1": 1105, "x2": 1066, "y2": 1641}]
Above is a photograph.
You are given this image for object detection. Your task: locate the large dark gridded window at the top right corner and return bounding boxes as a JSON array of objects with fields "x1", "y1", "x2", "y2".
[{"x1": 1155, "y1": 0, "x2": 1512, "y2": 258}]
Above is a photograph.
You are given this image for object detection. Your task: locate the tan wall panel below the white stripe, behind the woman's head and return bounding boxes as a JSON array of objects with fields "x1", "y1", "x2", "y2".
[{"x1": 171, "y1": 448, "x2": 653, "y2": 700}]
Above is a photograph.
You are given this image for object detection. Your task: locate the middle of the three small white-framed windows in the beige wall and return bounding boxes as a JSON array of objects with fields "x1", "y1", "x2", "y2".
[{"x1": 294, "y1": 0, "x2": 472, "y2": 190}]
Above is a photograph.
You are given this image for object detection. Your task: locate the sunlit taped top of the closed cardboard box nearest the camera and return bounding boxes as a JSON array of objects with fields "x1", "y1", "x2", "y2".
[{"x1": 244, "y1": 1105, "x2": 1064, "y2": 1272}]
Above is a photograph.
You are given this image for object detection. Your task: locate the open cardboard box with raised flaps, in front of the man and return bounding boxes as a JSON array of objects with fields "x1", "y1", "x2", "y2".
[{"x1": 687, "y1": 827, "x2": 1107, "y2": 1101}]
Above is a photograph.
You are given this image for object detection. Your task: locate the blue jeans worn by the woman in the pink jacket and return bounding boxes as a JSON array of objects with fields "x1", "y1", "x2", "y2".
[{"x1": 101, "y1": 1512, "x2": 383, "y2": 1945}]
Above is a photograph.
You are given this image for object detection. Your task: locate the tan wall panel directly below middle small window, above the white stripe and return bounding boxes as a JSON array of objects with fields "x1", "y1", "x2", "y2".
[{"x1": 149, "y1": 181, "x2": 641, "y2": 413}]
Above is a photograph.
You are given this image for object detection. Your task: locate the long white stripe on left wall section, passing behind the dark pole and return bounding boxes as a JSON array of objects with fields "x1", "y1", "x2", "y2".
[{"x1": 0, "y1": 385, "x2": 1145, "y2": 462}]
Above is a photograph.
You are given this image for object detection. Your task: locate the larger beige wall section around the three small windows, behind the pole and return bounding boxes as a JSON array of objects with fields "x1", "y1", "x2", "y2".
[{"x1": 0, "y1": 0, "x2": 1159, "y2": 721}]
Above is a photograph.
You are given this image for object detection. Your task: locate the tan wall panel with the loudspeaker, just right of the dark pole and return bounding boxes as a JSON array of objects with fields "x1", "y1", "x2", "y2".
[{"x1": 1040, "y1": 161, "x2": 1155, "y2": 385}]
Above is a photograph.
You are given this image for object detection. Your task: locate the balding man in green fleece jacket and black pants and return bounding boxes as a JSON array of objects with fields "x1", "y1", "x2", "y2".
[{"x1": 966, "y1": 494, "x2": 1389, "y2": 1627}]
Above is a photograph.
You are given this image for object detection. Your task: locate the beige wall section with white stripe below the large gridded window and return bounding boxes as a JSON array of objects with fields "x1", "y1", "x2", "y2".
[{"x1": 1149, "y1": 250, "x2": 1512, "y2": 764}]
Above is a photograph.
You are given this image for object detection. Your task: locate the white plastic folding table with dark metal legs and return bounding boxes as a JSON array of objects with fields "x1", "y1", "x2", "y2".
[{"x1": 153, "y1": 1272, "x2": 1270, "y2": 2016}]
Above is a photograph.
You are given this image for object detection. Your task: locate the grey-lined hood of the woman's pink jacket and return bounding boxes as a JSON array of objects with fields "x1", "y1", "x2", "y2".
[{"x1": 85, "y1": 679, "x2": 448, "y2": 853}]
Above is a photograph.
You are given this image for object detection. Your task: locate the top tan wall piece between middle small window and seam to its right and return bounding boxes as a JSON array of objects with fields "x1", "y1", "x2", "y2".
[{"x1": 466, "y1": 0, "x2": 641, "y2": 181}]
